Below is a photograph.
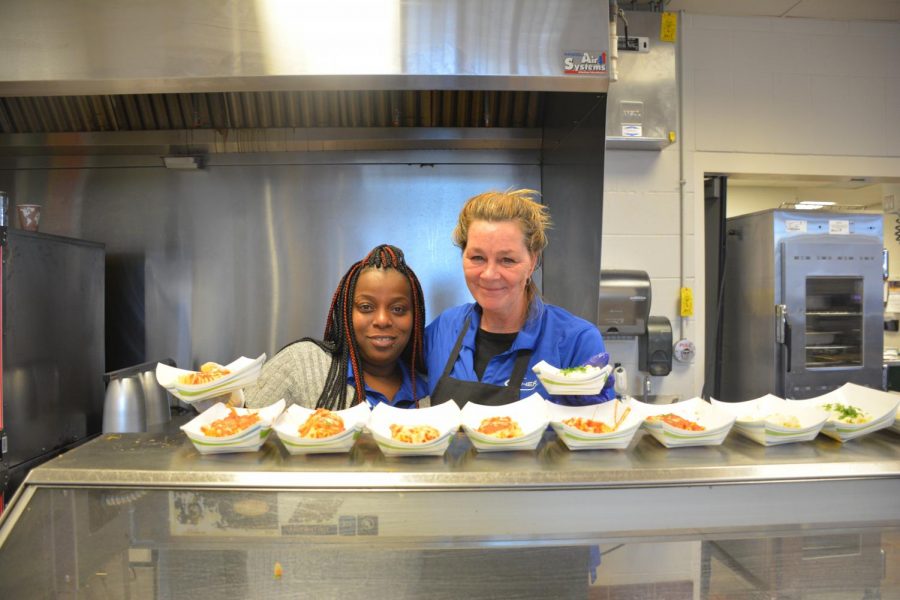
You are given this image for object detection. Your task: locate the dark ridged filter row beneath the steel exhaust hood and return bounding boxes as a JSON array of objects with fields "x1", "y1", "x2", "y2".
[{"x1": 0, "y1": 90, "x2": 542, "y2": 133}]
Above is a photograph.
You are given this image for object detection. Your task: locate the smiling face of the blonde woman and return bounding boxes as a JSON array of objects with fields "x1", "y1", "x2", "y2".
[{"x1": 463, "y1": 221, "x2": 537, "y2": 333}]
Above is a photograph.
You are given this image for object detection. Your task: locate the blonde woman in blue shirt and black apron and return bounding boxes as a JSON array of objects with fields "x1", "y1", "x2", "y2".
[{"x1": 425, "y1": 189, "x2": 614, "y2": 406}]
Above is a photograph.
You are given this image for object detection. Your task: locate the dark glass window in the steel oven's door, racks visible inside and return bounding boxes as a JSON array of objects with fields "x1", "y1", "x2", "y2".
[{"x1": 806, "y1": 277, "x2": 863, "y2": 369}]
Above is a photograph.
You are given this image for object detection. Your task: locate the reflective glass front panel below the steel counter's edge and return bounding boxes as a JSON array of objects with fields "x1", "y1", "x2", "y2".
[{"x1": 0, "y1": 488, "x2": 900, "y2": 600}]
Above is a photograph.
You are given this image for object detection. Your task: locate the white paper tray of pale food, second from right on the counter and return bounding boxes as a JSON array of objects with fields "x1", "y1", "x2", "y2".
[{"x1": 712, "y1": 394, "x2": 828, "y2": 446}]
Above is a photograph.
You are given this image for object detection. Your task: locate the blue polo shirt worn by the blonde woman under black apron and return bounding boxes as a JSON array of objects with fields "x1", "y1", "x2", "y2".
[{"x1": 425, "y1": 298, "x2": 615, "y2": 406}]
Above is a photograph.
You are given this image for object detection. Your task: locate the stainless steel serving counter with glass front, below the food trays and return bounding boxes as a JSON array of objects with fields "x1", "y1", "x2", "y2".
[{"x1": 0, "y1": 431, "x2": 900, "y2": 599}]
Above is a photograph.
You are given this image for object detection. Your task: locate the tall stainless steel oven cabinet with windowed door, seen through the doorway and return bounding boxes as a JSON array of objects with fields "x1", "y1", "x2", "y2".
[{"x1": 721, "y1": 210, "x2": 883, "y2": 401}]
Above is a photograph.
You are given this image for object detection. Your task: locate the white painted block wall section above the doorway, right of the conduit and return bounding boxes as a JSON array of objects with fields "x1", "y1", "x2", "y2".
[{"x1": 684, "y1": 15, "x2": 900, "y2": 156}]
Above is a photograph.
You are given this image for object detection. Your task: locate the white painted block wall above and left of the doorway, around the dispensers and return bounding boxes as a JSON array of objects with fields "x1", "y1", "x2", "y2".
[{"x1": 602, "y1": 14, "x2": 900, "y2": 398}]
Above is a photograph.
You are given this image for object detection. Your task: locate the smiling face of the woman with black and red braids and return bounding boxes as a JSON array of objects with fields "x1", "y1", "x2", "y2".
[{"x1": 353, "y1": 268, "x2": 413, "y2": 371}]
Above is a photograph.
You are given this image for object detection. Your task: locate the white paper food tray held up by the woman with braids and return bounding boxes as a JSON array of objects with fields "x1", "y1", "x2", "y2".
[{"x1": 156, "y1": 354, "x2": 266, "y2": 412}]
